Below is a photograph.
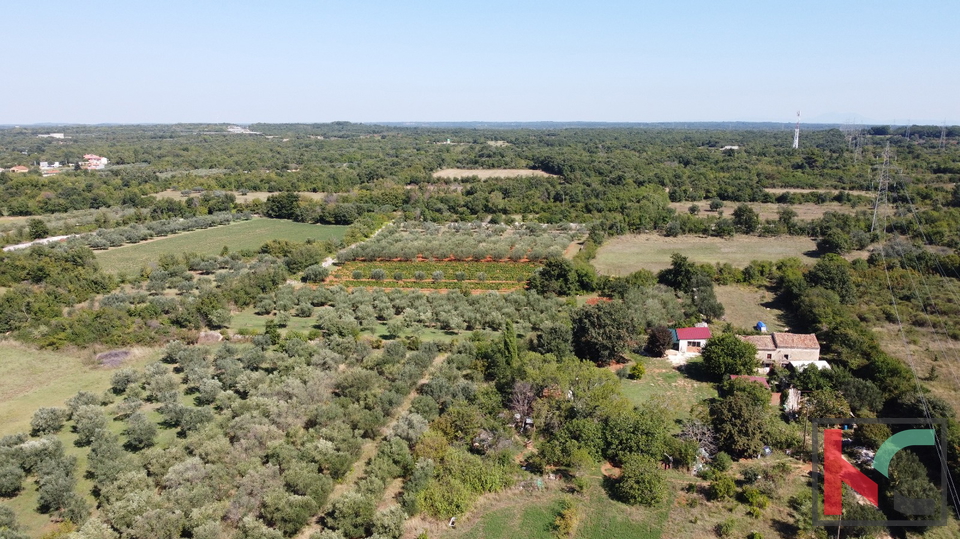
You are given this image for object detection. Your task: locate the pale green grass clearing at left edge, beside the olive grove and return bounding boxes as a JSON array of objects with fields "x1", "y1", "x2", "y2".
[{"x1": 0, "y1": 341, "x2": 160, "y2": 436}]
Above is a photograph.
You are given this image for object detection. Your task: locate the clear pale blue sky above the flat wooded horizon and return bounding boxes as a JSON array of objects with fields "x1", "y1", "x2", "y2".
[{"x1": 0, "y1": 0, "x2": 960, "y2": 125}]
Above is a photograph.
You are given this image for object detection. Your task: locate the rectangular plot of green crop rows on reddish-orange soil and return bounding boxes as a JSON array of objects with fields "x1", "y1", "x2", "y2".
[{"x1": 330, "y1": 261, "x2": 540, "y2": 290}]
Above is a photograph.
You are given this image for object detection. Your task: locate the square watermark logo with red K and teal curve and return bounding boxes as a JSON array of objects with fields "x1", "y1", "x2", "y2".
[{"x1": 811, "y1": 418, "x2": 948, "y2": 526}]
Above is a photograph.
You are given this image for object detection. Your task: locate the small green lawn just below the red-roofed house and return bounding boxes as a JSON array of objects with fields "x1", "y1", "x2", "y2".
[{"x1": 621, "y1": 358, "x2": 717, "y2": 428}]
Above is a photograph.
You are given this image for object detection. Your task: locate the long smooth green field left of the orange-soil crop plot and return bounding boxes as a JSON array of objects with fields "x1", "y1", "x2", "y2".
[{"x1": 97, "y1": 219, "x2": 347, "y2": 273}]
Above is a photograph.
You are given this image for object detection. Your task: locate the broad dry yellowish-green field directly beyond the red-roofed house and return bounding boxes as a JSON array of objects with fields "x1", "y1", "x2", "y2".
[{"x1": 593, "y1": 234, "x2": 817, "y2": 275}]
